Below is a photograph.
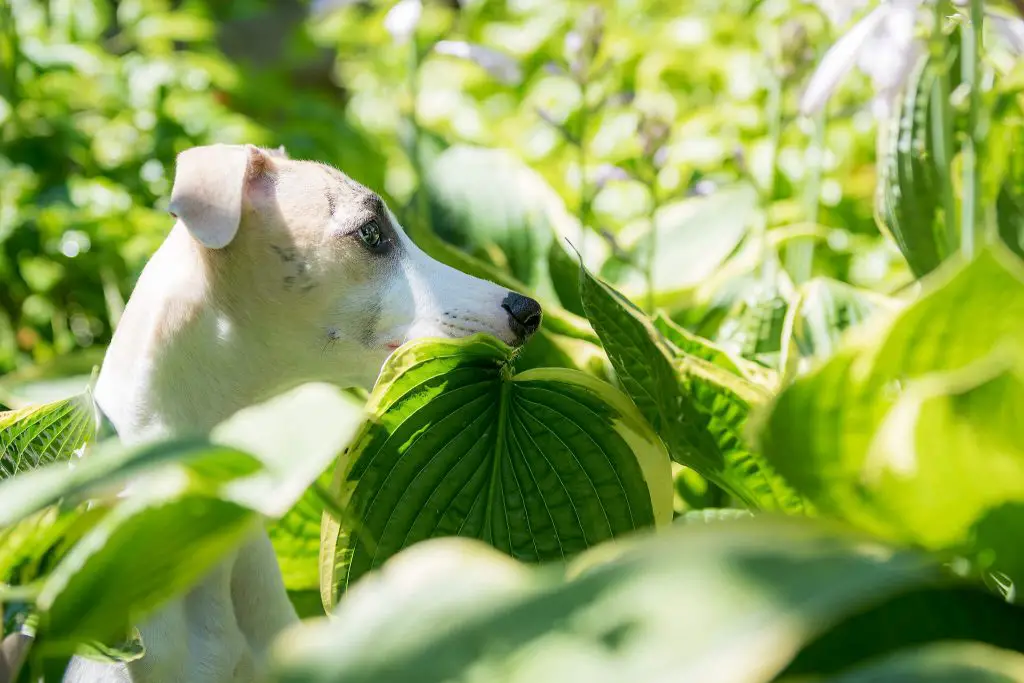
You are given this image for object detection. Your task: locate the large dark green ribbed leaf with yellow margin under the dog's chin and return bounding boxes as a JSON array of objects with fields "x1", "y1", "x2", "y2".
[{"x1": 322, "y1": 336, "x2": 672, "y2": 604}]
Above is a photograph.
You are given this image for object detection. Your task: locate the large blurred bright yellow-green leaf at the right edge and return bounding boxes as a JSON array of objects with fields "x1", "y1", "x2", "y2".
[{"x1": 762, "y1": 245, "x2": 1024, "y2": 577}]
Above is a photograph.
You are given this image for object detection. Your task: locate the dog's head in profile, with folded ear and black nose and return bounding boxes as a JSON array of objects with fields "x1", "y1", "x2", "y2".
[{"x1": 169, "y1": 144, "x2": 541, "y2": 386}]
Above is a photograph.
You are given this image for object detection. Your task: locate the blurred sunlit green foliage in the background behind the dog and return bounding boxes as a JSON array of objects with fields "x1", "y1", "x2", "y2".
[{"x1": 0, "y1": 0, "x2": 907, "y2": 385}]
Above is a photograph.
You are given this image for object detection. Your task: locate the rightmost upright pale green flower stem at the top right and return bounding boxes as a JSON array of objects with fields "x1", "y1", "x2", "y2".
[{"x1": 961, "y1": 0, "x2": 984, "y2": 258}]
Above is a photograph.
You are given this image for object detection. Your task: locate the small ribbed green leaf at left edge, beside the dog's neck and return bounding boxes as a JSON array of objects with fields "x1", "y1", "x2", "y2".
[{"x1": 0, "y1": 392, "x2": 97, "y2": 479}]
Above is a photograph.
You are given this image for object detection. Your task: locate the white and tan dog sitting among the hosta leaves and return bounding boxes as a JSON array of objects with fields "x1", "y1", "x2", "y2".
[{"x1": 65, "y1": 144, "x2": 541, "y2": 683}]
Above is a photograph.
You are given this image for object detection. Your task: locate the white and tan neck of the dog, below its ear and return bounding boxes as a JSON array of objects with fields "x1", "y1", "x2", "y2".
[{"x1": 95, "y1": 224, "x2": 292, "y2": 442}]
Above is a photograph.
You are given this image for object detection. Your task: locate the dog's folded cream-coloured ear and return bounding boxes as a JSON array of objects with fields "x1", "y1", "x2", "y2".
[{"x1": 168, "y1": 144, "x2": 272, "y2": 249}]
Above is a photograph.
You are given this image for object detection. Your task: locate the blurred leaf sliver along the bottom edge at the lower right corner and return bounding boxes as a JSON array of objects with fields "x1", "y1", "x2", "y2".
[{"x1": 802, "y1": 642, "x2": 1024, "y2": 683}]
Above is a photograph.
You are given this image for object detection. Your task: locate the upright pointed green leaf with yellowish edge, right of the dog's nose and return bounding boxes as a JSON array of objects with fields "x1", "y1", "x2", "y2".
[{"x1": 581, "y1": 268, "x2": 804, "y2": 512}]
